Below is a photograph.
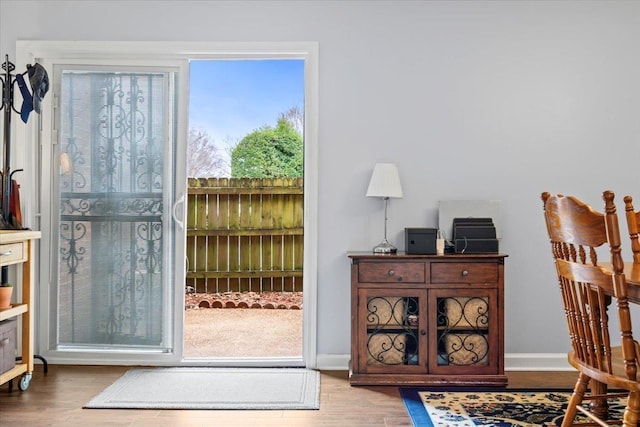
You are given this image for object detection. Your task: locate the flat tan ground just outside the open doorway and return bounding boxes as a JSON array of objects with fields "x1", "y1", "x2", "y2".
[{"x1": 184, "y1": 308, "x2": 302, "y2": 358}]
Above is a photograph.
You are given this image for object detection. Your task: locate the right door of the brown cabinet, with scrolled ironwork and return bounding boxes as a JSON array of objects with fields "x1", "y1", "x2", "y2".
[{"x1": 429, "y1": 289, "x2": 498, "y2": 374}]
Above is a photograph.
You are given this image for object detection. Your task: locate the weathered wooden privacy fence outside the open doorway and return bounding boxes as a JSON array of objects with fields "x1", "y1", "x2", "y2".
[{"x1": 186, "y1": 178, "x2": 304, "y2": 293}]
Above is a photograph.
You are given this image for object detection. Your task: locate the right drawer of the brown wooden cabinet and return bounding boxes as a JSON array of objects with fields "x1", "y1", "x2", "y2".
[{"x1": 431, "y1": 262, "x2": 498, "y2": 283}]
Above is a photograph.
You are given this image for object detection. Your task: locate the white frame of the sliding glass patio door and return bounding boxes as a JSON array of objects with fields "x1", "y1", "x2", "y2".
[{"x1": 12, "y1": 41, "x2": 319, "y2": 368}]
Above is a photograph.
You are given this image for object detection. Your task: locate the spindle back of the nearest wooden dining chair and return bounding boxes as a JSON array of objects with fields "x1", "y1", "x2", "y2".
[{"x1": 542, "y1": 191, "x2": 637, "y2": 380}]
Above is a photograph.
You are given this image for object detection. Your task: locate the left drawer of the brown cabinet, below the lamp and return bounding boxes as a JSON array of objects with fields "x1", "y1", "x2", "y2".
[{"x1": 358, "y1": 262, "x2": 425, "y2": 283}]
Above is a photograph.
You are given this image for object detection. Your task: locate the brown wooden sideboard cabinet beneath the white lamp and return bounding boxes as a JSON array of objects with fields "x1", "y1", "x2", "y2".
[{"x1": 348, "y1": 252, "x2": 507, "y2": 386}]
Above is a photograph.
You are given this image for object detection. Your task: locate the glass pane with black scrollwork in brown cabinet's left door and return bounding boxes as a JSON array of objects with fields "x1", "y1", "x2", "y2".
[{"x1": 366, "y1": 296, "x2": 420, "y2": 366}]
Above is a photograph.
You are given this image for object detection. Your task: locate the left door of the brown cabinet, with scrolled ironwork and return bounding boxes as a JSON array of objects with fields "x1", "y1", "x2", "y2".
[{"x1": 358, "y1": 289, "x2": 427, "y2": 372}]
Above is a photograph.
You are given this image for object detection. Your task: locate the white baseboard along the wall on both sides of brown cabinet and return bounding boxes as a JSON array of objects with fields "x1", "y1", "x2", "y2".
[{"x1": 317, "y1": 353, "x2": 574, "y2": 371}]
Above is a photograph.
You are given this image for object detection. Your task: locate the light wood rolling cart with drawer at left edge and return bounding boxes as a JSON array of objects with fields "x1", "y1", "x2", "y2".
[{"x1": 0, "y1": 230, "x2": 41, "y2": 391}]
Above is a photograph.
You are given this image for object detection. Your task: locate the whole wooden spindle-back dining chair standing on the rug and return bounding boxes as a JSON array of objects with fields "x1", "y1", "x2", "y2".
[{"x1": 542, "y1": 191, "x2": 640, "y2": 427}]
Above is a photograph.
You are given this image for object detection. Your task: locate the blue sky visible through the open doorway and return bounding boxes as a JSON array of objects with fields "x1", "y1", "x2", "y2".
[{"x1": 189, "y1": 60, "x2": 304, "y2": 146}]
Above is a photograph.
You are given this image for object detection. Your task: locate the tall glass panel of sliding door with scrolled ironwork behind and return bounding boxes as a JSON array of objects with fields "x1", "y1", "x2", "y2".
[{"x1": 53, "y1": 70, "x2": 173, "y2": 350}]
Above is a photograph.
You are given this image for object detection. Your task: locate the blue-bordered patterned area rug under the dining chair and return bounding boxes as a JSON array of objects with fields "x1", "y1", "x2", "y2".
[{"x1": 400, "y1": 388, "x2": 624, "y2": 427}]
